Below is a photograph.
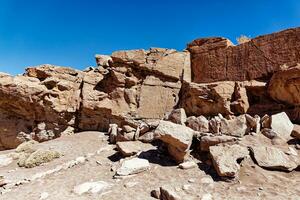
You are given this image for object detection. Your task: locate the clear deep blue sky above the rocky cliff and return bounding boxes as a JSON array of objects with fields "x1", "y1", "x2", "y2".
[{"x1": 0, "y1": 0, "x2": 300, "y2": 74}]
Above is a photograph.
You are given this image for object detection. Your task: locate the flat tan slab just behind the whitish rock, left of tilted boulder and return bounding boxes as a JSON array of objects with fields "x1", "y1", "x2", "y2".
[{"x1": 116, "y1": 141, "x2": 156, "y2": 156}]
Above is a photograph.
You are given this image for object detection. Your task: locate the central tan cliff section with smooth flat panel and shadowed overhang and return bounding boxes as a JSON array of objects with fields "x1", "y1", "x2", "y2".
[{"x1": 79, "y1": 48, "x2": 190, "y2": 130}]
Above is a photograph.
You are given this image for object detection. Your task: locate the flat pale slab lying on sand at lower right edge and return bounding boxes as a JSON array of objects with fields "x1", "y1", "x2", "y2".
[{"x1": 251, "y1": 146, "x2": 299, "y2": 171}]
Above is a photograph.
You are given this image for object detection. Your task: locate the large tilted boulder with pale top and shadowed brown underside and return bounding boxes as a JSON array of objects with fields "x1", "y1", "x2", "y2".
[{"x1": 155, "y1": 120, "x2": 194, "y2": 162}]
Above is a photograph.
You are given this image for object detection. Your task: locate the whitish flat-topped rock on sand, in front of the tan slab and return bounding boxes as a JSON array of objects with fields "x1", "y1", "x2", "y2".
[{"x1": 116, "y1": 158, "x2": 150, "y2": 176}]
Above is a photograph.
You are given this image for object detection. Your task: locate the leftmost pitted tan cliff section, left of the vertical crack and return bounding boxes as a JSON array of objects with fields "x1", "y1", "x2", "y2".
[{"x1": 0, "y1": 65, "x2": 83, "y2": 149}]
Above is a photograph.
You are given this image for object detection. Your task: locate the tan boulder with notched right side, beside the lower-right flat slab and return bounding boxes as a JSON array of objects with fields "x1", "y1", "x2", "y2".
[{"x1": 209, "y1": 144, "x2": 249, "y2": 177}]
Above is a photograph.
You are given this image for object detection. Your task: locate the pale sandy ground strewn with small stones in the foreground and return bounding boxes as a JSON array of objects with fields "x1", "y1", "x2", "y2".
[{"x1": 0, "y1": 132, "x2": 300, "y2": 200}]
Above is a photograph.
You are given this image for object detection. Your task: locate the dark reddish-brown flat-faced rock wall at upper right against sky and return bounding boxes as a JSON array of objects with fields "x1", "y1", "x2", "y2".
[{"x1": 188, "y1": 28, "x2": 300, "y2": 83}]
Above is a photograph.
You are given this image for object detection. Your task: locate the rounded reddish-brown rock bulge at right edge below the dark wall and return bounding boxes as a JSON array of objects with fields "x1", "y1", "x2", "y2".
[{"x1": 268, "y1": 65, "x2": 300, "y2": 106}]
